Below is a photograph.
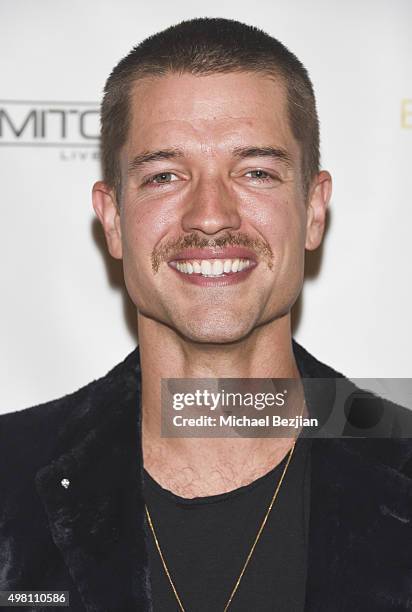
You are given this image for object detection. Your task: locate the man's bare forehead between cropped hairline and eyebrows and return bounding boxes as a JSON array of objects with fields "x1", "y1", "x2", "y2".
[{"x1": 125, "y1": 73, "x2": 298, "y2": 156}]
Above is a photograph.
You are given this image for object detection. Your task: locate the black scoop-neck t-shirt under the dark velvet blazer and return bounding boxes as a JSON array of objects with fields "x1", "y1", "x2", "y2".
[{"x1": 144, "y1": 438, "x2": 310, "y2": 612}]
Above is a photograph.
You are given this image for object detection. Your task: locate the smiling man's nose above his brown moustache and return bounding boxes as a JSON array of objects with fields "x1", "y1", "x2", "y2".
[{"x1": 182, "y1": 176, "x2": 241, "y2": 235}]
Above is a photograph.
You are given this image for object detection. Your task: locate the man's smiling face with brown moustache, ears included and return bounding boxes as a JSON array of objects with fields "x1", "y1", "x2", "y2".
[{"x1": 94, "y1": 73, "x2": 330, "y2": 343}]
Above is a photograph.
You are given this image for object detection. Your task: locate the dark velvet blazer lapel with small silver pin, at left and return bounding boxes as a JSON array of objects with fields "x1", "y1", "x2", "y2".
[{"x1": 36, "y1": 351, "x2": 151, "y2": 612}]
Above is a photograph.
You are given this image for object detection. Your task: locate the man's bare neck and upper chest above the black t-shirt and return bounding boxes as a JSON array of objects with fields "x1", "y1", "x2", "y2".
[{"x1": 138, "y1": 315, "x2": 299, "y2": 497}]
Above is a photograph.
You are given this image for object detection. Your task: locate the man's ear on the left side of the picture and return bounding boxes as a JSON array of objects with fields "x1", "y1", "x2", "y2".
[{"x1": 92, "y1": 181, "x2": 123, "y2": 259}]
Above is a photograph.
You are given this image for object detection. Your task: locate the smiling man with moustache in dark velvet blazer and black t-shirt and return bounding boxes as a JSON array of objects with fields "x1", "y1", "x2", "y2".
[{"x1": 0, "y1": 19, "x2": 412, "y2": 612}]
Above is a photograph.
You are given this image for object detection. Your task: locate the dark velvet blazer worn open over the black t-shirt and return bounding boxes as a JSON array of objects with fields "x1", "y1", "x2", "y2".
[{"x1": 0, "y1": 343, "x2": 412, "y2": 612}]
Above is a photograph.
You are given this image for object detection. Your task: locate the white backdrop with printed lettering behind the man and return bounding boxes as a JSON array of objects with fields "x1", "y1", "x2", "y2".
[{"x1": 0, "y1": 0, "x2": 412, "y2": 412}]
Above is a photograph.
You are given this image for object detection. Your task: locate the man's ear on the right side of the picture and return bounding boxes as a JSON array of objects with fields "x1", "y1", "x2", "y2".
[{"x1": 305, "y1": 170, "x2": 332, "y2": 251}]
